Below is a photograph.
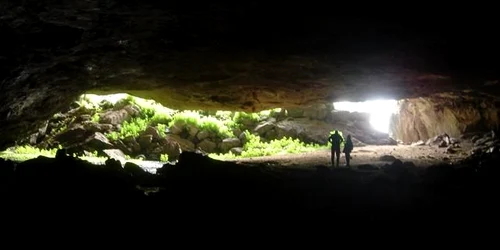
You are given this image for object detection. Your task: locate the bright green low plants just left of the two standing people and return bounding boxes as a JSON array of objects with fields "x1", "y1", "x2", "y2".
[{"x1": 209, "y1": 131, "x2": 328, "y2": 160}]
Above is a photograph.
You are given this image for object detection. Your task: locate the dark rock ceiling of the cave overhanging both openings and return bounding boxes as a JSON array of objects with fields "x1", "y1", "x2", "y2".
[{"x1": 0, "y1": 0, "x2": 500, "y2": 148}]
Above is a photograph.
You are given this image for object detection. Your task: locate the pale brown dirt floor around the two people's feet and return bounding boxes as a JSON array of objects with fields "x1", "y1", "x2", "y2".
[{"x1": 227, "y1": 143, "x2": 472, "y2": 169}]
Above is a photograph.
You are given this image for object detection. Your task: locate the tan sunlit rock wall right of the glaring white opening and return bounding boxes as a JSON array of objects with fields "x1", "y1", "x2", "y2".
[{"x1": 391, "y1": 92, "x2": 500, "y2": 143}]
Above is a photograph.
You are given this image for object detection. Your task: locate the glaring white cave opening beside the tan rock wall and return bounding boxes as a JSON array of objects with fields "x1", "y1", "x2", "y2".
[{"x1": 333, "y1": 100, "x2": 398, "y2": 133}]
